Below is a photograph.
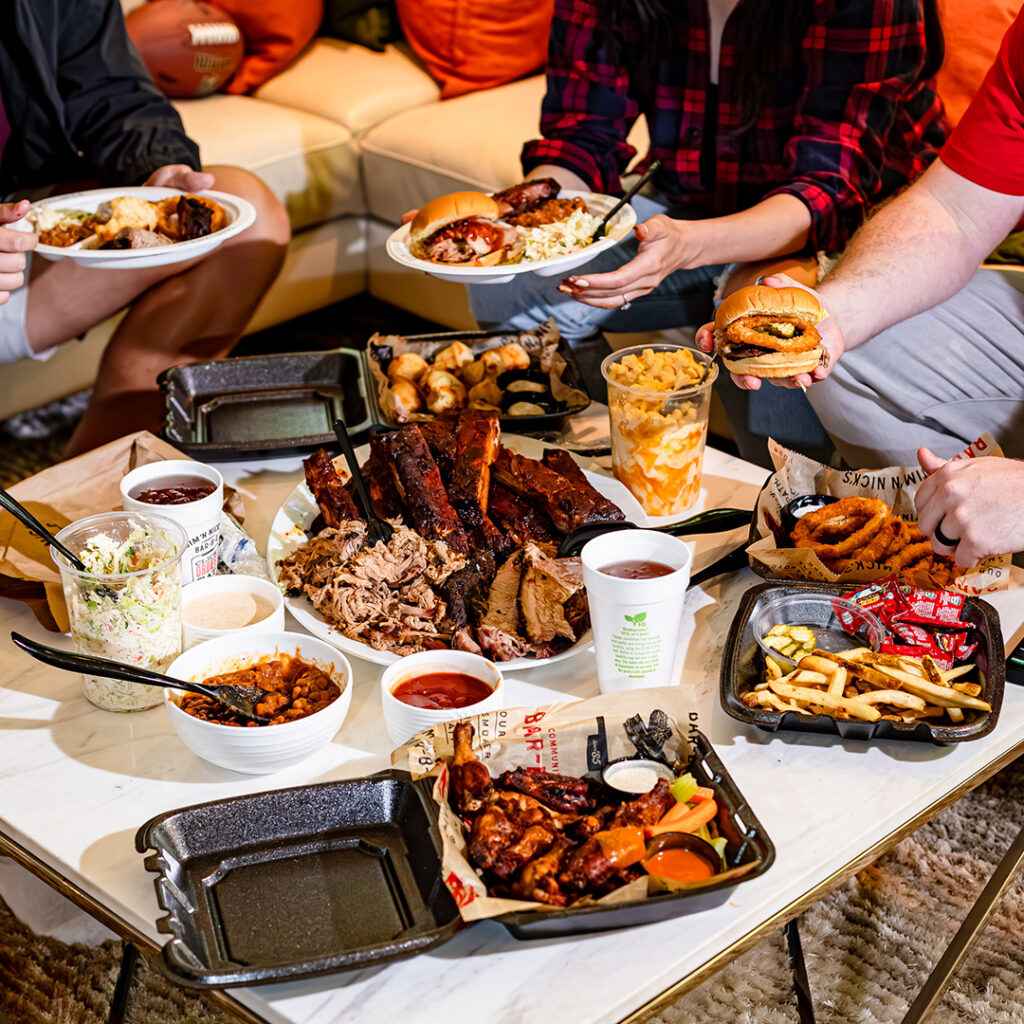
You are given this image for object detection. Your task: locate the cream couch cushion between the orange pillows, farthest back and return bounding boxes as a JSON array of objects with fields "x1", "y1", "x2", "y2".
[{"x1": 255, "y1": 39, "x2": 440, "y2": 134}]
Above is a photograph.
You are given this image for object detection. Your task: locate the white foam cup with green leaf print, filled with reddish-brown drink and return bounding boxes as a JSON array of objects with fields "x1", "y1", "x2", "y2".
[{"x1": 580, "y1": 529, "x2": 693, "y2": 693}]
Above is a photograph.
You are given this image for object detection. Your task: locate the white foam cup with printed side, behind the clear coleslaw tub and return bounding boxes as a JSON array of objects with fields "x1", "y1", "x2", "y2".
[{"x1": 121, "y1": 459, "x2": 224, "y2": 585}]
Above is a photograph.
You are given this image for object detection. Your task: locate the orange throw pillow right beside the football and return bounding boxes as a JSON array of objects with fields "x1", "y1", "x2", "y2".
[{"x1": 213, "y1": 0, "x2": 324, "y2": 92}]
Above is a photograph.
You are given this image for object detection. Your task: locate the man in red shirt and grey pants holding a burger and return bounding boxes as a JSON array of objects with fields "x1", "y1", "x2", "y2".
[{"x1": 697, "y1": 4, "x2": 1024, "y2": 565}]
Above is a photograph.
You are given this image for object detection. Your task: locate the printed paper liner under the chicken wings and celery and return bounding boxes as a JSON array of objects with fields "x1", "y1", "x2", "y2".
[{"x1": 391, "y1": 682, "x2": 712, "y2": 921}]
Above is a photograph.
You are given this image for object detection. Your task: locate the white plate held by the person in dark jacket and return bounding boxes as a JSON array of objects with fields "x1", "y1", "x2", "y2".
[{"x1": 9, "y1": 185, "x2": 256, "y2": 270}]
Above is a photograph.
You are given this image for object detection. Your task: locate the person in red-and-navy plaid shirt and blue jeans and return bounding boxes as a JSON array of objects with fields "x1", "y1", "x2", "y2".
[{"x1": 469, "y1": 0, "x2": 945, "y2": 461}]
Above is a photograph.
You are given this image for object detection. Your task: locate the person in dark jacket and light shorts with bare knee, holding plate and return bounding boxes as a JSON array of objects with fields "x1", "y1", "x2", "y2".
[{"x1": 0, "y1": 0, "x2": 290, "y2": 455}]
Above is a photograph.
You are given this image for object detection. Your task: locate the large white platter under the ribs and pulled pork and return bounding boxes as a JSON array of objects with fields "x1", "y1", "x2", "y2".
[{"x1": 266, "y1": 434, "x2": 648, "y2": 672}]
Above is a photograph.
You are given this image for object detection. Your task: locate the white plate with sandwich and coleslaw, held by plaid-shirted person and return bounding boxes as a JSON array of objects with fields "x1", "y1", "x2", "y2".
[{"x1": 387, "y1": 189, "x2": 637, "y2": 285}]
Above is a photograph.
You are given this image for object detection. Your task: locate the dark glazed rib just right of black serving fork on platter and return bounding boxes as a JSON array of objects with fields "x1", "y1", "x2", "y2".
[{"x1": 382, "y1": 425, "x2": 469, "y2": 552}]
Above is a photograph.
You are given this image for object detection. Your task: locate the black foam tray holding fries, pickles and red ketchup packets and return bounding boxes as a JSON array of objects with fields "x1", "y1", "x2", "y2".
[{"x1": 719, "y1": 582, "x2": 1007, "y2": 743}]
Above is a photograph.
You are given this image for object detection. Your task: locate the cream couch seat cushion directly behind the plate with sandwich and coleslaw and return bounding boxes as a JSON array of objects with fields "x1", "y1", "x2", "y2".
[{"x1": 359, "y1": 75, "x2": 647, "y2": 224}]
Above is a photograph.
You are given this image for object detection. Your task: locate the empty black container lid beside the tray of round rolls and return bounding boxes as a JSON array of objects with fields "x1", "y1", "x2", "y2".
[{"x1": 158, "y1": 348, "x2": 373, "y2": 460}]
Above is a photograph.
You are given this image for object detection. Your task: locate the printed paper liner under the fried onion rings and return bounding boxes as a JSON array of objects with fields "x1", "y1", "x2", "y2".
[{"x1": 746, "y1": 434, "x2": 1011, "y2": 595}]
